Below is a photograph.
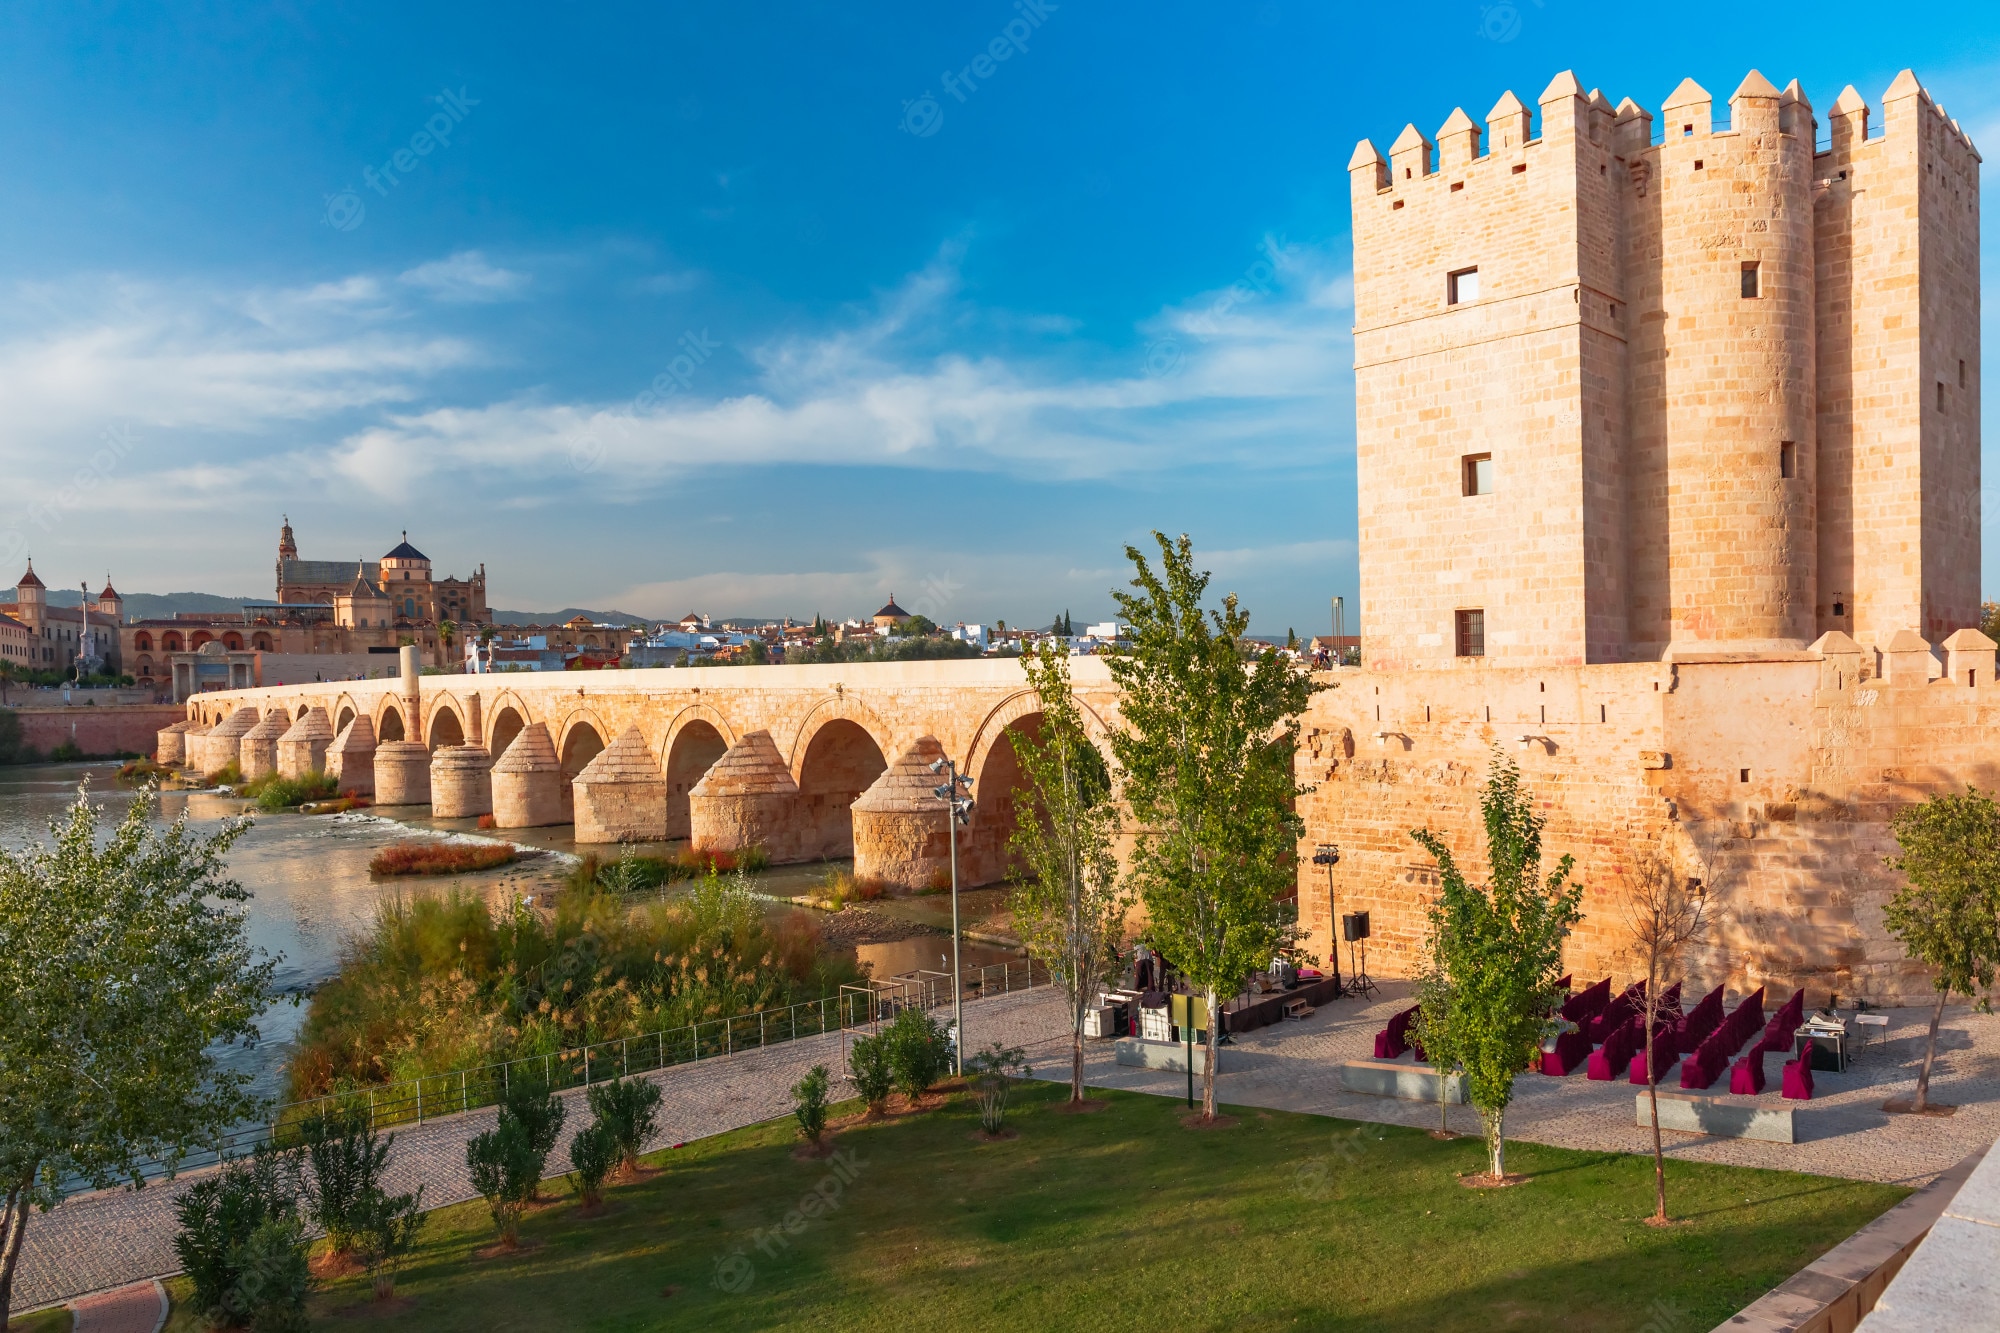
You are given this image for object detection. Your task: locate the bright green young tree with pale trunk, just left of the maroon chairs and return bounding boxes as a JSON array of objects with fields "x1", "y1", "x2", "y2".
[{"x1": 1410, "y1": 751, "x2": 1584, "y2": 1181}]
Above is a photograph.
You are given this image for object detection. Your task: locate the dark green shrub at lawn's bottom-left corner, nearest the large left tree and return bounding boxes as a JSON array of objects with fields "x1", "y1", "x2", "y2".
[{"x1": 174, "y1": 1151, "x2": 308, "y2": 1329}]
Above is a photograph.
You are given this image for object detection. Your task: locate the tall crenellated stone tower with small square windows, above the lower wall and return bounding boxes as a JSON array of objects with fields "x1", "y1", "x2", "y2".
[{"x1": 1348, "y1": 72, "x2": 1980, "y2": 669}]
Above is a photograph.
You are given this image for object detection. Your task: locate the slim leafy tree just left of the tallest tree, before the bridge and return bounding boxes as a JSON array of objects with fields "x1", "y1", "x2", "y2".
[{"x1": 1006, "y1": 642, "x2": 1132, "y2": 1103}]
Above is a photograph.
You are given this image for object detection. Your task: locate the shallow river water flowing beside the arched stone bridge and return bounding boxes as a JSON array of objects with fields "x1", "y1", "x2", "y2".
[{"x1": 0, "y1": 765, "x2": 1020, "y2": 1097}]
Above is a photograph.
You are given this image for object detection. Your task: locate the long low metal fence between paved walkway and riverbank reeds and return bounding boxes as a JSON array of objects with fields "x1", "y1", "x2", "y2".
[{"x1": 123, "y1": 959, "x2": 1048, "y2": 1179}]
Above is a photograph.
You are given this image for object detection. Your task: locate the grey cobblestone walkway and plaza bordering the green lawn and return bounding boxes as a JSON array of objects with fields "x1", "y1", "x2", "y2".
[{"x1": 16, "y1": 983, "x2": 2000, "y2": 1309}]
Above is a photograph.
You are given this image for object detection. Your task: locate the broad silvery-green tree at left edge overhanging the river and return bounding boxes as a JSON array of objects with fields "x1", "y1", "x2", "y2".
[{"x1": 0, "y1": 787, "x2": 274, "y2": 1327}]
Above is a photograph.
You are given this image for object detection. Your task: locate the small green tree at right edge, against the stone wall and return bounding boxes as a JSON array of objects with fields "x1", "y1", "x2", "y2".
[{"x1": 1882, "y1": 787, "x2": 2000, "y2": 1111}]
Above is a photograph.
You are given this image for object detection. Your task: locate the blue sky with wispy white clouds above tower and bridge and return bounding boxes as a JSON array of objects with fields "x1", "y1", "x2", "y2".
[{"x1": 0, "y1": 0, "x2": 2000, "y2": 632}]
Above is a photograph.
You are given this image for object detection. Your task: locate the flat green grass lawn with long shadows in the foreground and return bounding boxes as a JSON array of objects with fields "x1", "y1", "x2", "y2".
[{"x1": 168, "y1": 1085, "x2": 1908, "y2": 1333}]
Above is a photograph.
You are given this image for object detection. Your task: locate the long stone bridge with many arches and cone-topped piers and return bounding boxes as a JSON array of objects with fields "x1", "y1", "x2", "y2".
[{"x1": 158, "y1": 656, "x2": 1116, "y2": 889}]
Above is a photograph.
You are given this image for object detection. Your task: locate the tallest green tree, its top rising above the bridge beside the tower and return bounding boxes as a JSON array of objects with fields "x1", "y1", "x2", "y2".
[{"x1": 1110, "y1": 532, "x2": 1316, "y2": 1119}]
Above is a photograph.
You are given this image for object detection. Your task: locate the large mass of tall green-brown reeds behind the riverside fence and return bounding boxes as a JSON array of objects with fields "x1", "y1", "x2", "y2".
[{"x1": 288, "y1": 873, "x2": 862, "y2": 1099}]
